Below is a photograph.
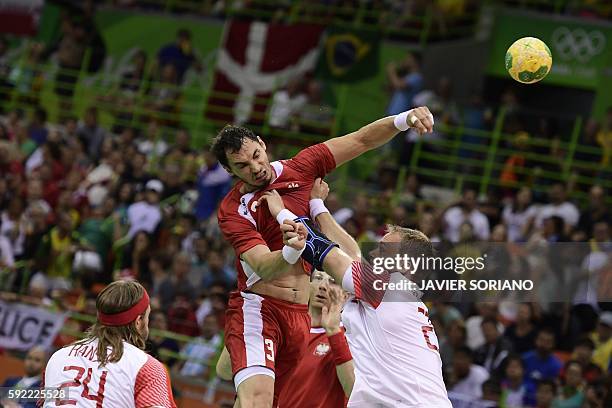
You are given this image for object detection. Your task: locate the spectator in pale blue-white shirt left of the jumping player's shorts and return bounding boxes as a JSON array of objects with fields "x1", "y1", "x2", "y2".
[{"x1": 179, "y1": 314, "x2": 223, "y2": 378}]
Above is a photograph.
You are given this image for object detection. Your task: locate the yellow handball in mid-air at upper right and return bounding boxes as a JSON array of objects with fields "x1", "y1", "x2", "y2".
[{"x1": 506, "y1": 37, "x2": 552, "y2": 84}]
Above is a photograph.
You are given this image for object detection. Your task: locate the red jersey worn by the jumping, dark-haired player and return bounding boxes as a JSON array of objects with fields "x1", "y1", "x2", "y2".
[{"x1": 218, "y1": 143, "x2": 336, "y2": 291}]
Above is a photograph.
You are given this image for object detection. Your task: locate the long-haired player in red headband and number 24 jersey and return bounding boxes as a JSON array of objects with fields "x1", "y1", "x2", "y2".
[{"x1": 43, "y1": 281, "x2": 176, "y2": 408}]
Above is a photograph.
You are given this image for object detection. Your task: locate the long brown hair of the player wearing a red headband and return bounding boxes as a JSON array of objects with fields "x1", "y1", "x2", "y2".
[{"x1": 77, "y1": 281, "x2": 146, "y2": 366}]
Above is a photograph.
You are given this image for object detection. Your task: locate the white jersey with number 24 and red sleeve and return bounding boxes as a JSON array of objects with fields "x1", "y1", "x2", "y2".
[{"x1": 43, "y1": 339, "x2": 176, "y2": 408}]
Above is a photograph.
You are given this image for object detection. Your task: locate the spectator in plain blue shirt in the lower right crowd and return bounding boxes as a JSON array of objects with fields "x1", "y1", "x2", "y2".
[{"x1": 523, "y1": 328, "x2": 562, "y2": 397}]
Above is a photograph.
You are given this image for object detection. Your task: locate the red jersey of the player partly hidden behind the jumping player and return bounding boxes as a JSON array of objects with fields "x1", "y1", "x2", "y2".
[{"x1": 278, "y1": 327, "x2": 348, "y2": 408}]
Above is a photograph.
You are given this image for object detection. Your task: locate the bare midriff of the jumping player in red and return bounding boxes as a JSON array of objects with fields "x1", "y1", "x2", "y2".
[{"x1": 250, "y1": 265, "x2": 310, "y2": 304}]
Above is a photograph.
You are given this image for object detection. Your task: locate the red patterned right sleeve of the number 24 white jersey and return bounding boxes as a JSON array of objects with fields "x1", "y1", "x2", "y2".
[{"x1": 134, "y1": 356, "x2": 176, "y2": 408}]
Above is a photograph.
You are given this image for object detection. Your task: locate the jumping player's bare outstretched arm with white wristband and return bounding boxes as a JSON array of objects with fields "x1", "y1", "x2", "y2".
[{"x1": 324, "y1": 107, "x2": 433, "y2": 167}]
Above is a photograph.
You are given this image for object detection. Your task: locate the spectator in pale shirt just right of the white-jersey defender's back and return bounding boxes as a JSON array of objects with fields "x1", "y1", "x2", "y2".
[{"x1": 449, "y1": 347, "x2": 489, "y2": 399}]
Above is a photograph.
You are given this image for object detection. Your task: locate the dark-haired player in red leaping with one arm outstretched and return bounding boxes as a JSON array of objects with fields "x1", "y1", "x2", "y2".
[{"x1": 212, "y1": 107, "x2": 433, "y2": 408}]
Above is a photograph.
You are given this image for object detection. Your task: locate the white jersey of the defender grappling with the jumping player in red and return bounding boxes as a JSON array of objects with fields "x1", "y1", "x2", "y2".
[{"x1": 342, "y1": 274, "x2": 452, "y2": 408}]
